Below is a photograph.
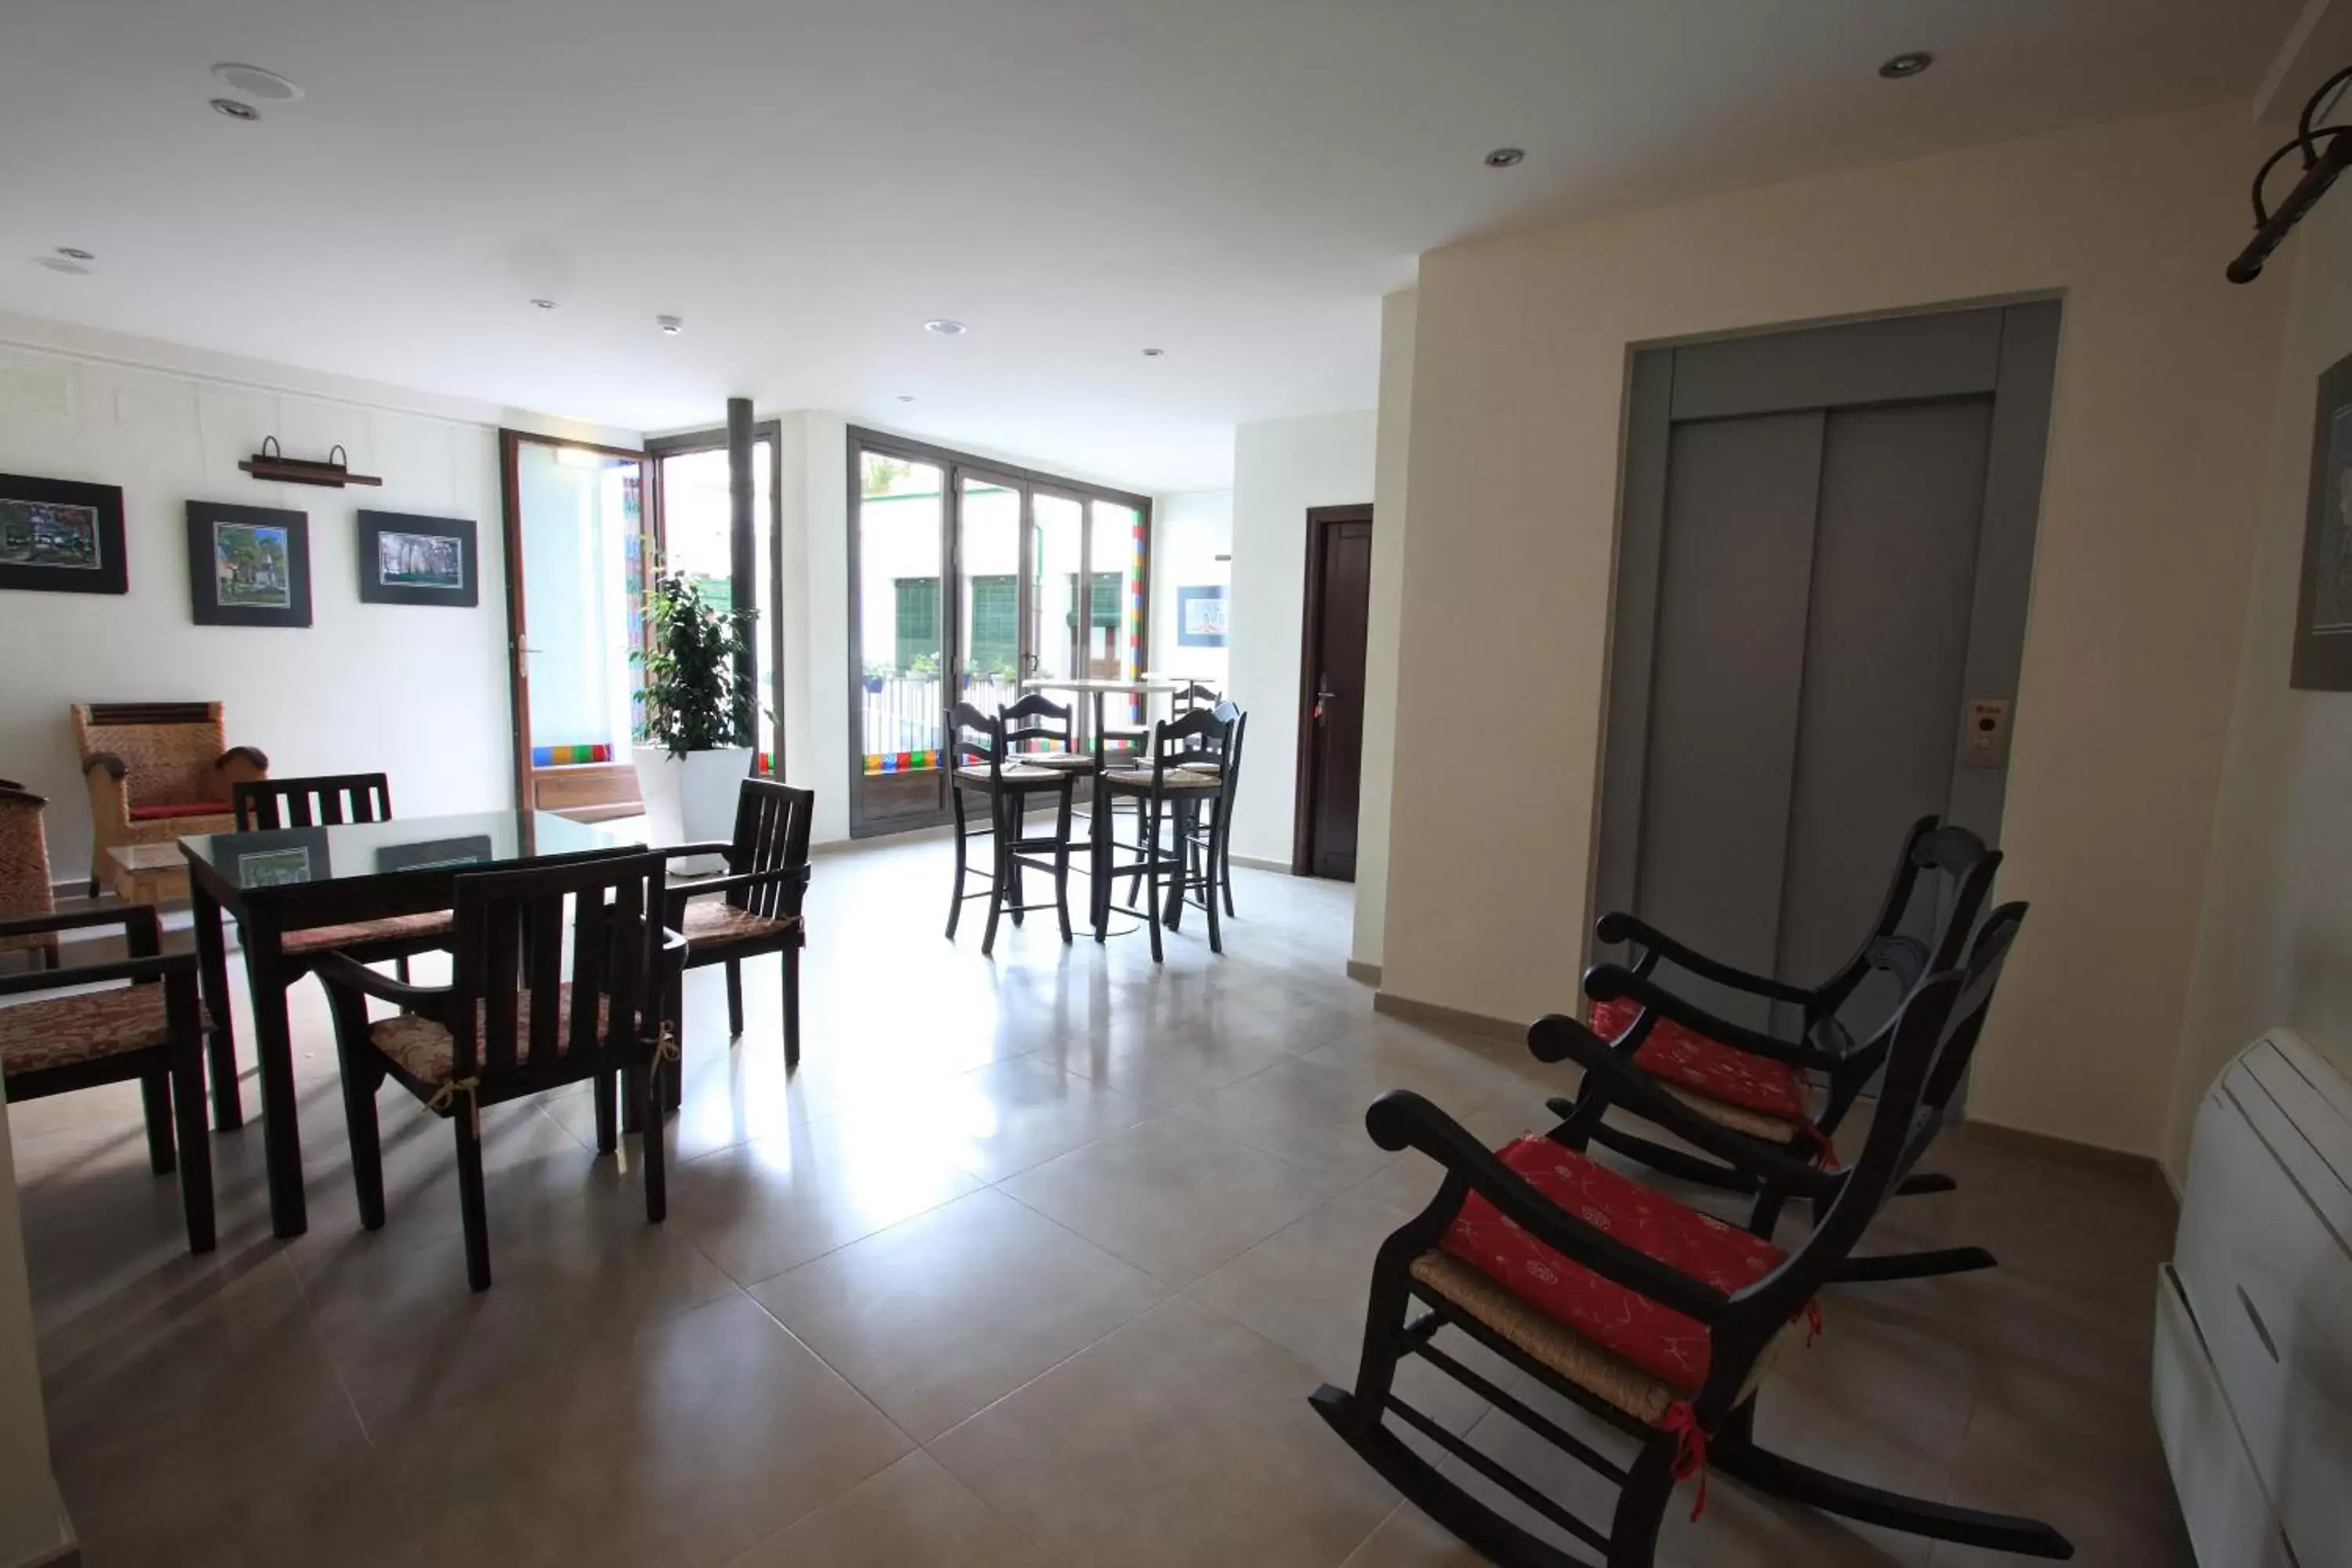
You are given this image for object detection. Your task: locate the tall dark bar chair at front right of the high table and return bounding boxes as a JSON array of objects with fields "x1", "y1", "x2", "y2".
[{"x1": 1094, "y1": 708, "x2": 1232, "y2": 964}]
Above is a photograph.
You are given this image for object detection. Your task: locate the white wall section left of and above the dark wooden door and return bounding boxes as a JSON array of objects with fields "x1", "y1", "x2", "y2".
[{"x1": 1228, "y1": 409, "x2": 1381, "y2": 867}]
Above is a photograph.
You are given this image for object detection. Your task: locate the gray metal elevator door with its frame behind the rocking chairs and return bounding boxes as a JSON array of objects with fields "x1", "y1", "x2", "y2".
[{"x1": 1595, "y1": 306, "x2": 2056, "y2": 1044}]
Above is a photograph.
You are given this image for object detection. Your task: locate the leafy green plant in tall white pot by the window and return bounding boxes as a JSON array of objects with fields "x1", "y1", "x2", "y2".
[{"x1": 630, "y1": 572, "x2": 757, "y2": 844}]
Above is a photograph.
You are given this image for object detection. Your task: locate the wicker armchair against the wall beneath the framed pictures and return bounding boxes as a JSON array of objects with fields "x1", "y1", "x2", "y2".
[{"x1": 73, "y1": 703, "x2": 270, "y2": 898}]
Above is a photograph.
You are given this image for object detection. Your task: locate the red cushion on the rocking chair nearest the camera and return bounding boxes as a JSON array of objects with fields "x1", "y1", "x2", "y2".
[{"x1": 1442, "y1": 1135, "x2": 1788, "y2": 1394}]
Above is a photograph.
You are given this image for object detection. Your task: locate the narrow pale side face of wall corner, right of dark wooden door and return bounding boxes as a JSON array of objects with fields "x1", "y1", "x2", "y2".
[{"x1": 1348, "y1": 289, "x2": 1416, "y2": 968}]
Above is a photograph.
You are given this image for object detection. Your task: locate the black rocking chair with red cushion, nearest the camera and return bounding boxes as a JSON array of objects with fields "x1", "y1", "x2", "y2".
[{"x1": 1312, "y1": 909, "x2": 2074, "y2": 1568}]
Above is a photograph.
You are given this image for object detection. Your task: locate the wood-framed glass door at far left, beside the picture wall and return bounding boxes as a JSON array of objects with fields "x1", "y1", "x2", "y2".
[{"x1": 499, "y1": 430, "x2": 649, "y2": 820}]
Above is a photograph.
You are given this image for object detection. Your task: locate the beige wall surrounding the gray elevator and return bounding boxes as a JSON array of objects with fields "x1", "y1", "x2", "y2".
[{"x1": 1383, "y1": 106, "x2": 2279, "y2": 1152}]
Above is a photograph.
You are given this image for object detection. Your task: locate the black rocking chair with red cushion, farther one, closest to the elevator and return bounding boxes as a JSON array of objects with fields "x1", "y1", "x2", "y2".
[{"x1": 1573, "y1": 815, "x2": 2002, "y2": 1234}]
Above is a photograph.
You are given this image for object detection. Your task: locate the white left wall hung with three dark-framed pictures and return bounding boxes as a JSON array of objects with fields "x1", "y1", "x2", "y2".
[{"x1": 0, "y1": 318, "x2": 635, "y2": 879}]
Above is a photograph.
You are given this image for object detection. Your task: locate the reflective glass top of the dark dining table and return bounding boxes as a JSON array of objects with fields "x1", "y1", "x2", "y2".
[{"x1": 179, "y1": 811, "x2": 644, "y2": 891}]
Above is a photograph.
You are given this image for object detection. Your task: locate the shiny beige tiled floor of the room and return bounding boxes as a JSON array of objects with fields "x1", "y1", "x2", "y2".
[{"x1": 9, "y1": 841, "x2": 2187, "y2": 1568}]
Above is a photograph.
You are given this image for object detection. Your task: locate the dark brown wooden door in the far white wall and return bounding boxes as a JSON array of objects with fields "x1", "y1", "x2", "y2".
[{"x1": 1291, "y1": 506, "x2": 1371, "y2": 881}]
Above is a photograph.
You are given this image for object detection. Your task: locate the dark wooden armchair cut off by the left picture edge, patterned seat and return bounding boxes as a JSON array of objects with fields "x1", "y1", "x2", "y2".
[{"x1": 0, "y1": 905, "x2": 214, "y2": 1253}]
